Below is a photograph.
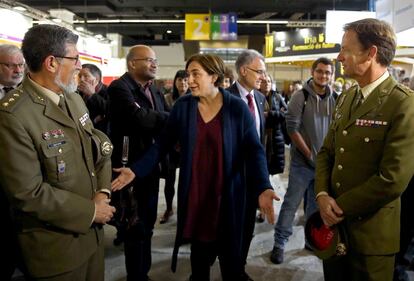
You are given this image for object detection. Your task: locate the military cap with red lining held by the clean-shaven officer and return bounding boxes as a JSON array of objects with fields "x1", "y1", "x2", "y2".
[{"x1": 305, "y1": 211, "x2": 347, "y2": 260}]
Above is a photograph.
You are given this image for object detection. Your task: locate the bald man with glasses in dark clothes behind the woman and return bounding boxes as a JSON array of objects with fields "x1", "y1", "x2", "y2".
[{"x1": 108, "y1": 45, "x2": 168, "y2": 281}]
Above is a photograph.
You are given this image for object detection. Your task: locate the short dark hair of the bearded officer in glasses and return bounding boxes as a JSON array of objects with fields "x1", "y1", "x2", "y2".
[{"x1": 22, "y1": 24, "x2": 78, "y2": 72}]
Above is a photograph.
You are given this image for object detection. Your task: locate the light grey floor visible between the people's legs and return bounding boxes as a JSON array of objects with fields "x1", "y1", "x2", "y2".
[{"x1": 105, "y1": 165, "x2": 323, "y2": 281}]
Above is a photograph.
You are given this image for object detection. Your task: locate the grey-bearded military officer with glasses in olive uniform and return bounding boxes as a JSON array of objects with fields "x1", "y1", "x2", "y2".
[{"x1": 0, "y1": 25, "x2": 115, "y2": 281}]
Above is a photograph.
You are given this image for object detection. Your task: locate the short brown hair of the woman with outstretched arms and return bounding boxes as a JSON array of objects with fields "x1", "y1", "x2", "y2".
[{"x1": 185, "y1": 54, "x2": 225, "y2": 87}]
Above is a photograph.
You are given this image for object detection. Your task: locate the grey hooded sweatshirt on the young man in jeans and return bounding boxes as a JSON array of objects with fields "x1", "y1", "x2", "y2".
[{"x1": 286, "y1": 79, "x2": 335, "y2": 167}]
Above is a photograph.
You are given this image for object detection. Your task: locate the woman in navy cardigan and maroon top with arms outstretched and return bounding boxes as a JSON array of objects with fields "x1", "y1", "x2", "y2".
[{"x1": 112, "y1": 54, "x2": 279, "y2": 281}]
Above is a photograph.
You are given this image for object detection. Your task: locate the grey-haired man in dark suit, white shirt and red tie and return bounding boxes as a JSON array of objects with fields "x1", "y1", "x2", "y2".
[{"x1": 227, "y1": 49, "x2": 266, "y2": 280}]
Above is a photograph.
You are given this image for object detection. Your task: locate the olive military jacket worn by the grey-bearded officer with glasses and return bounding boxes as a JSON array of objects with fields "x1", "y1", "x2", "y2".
[{"x1": 0, "y1": 77, "x2": 112, "y2": 277}]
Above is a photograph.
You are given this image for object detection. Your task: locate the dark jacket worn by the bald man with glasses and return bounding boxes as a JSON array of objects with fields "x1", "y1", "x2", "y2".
[{"x1": 108, "y1": 73, "x2": 168, "y2": 167}]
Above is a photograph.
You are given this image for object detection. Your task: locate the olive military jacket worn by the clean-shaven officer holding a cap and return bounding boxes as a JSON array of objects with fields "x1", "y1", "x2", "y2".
[{"x1": 315, "y1": 77, "x2": 414, "y2": 255}]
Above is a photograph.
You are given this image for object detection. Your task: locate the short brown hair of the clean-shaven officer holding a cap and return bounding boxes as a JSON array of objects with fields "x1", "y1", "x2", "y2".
[{"x1": 344, "y1": 19, "x2": 397, "y2": 66}]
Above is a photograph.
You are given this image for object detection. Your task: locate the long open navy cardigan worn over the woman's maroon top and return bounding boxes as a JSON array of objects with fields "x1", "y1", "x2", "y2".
[{"x1": 132, "y1": 89, "x2": 271, "y2": 271}]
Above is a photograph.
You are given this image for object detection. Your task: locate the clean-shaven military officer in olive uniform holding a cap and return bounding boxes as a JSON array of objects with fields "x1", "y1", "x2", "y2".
[{"x1": 315, "y1": 19, "x2": 414, "y2": 281}]
